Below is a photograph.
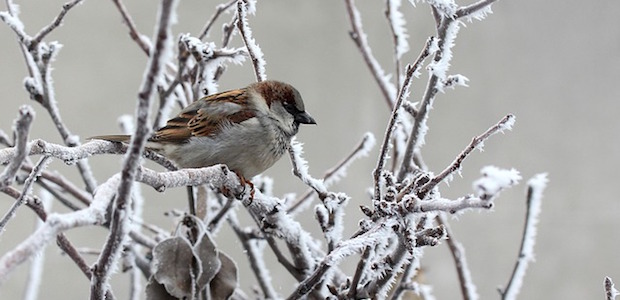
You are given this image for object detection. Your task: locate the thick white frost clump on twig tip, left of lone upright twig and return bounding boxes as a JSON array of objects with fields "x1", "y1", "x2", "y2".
[{"x1": 473, "y1": 166, "x2": 521, "y2": 200}]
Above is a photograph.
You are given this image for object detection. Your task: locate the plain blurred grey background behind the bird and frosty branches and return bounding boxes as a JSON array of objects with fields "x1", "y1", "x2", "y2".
[{"x1": 0, "y1": 0, "x2": 620, "y2": 299}]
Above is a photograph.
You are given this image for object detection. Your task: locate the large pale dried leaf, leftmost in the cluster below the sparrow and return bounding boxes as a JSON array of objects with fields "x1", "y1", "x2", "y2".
[{"x1": 153, "y1": 237, "x2": 194, "y2": 298}]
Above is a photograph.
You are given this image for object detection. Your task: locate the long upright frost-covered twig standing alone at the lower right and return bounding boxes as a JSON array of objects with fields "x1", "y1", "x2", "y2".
[{"x1": 500, "y1": 173, "x2": 548, "y2": 300}]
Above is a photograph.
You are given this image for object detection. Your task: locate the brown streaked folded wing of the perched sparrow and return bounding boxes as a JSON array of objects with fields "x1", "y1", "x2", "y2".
[{"x1": 149, "y1": 89, "x2": 256, "y2": 143}]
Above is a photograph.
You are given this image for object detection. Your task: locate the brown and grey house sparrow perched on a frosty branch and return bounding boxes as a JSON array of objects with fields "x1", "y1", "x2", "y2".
[{"x1": 91, "y1": 80, "x2": 316, "y2": 181}]
